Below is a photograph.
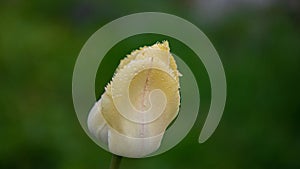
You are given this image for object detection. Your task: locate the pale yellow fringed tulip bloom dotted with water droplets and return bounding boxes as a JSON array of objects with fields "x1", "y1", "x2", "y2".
[{"x1": 88, "y1": 41, "x2": 180, "y2": 158}]
